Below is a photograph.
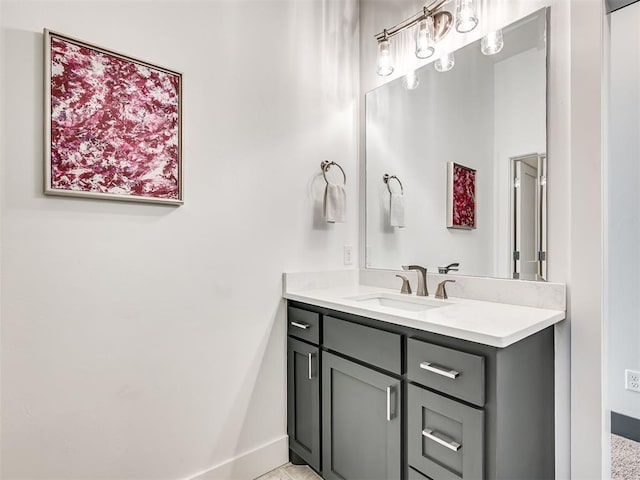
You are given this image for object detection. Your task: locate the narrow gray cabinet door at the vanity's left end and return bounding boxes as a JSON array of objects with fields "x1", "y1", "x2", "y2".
[{"x1": 287, "y1": 337, "x2": 320, "y2": 471}]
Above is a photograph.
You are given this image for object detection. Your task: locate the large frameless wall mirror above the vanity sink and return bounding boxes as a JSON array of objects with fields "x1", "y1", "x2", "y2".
[{"x1": 365, "y1": 9, "x2": 548, "y2": 280}]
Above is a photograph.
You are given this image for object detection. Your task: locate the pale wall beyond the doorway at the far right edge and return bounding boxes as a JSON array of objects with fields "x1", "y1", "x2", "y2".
[{"x1": 606, "y1": 3, "x2": 640, "y2": 419}]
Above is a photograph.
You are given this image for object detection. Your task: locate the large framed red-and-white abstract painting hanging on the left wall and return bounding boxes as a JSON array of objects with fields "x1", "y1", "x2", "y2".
[{"x1": 44, "y1": 29, "x2": 183, "y2": 205}]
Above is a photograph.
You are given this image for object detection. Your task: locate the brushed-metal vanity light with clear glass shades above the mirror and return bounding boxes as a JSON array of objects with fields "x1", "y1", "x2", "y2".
[{"x1": 375, "y1": 0, "x2": 478, "y2": 76}]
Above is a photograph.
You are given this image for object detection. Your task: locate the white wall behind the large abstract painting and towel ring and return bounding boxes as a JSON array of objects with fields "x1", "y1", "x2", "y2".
[{"x1": 0, "y1": 0, "x2": 358, "y2": 479}]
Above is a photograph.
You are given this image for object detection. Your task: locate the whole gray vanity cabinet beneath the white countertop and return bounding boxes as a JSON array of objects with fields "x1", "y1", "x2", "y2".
[{"x1": 288, "y1": 301, "x2": 555, "y2": 480}]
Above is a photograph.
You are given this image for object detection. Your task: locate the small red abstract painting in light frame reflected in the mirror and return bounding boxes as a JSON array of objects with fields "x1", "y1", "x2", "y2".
[{"x1": 447, "y1": 162, "x2": 476, "y2": 230}]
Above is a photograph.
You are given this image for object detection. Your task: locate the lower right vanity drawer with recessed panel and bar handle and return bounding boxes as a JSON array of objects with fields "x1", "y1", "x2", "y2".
[{"x1": 408, "y1": 385, "x2": 484, "y2": 480}]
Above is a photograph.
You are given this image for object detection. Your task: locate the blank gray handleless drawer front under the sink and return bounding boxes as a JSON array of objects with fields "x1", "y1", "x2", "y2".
[{"x1": 323, "y1": 317, "x2": 402, "y2": 375}]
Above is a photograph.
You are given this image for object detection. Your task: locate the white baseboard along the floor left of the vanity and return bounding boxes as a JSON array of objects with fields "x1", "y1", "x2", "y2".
[{"x1": 189, "y1": 435, "x2": 289, "y2": 480}]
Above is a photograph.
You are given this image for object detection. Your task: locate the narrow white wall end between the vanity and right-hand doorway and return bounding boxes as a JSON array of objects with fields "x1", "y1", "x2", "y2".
[{"x1": 568, "y1": 0, "x2": 609, "y2": 479}]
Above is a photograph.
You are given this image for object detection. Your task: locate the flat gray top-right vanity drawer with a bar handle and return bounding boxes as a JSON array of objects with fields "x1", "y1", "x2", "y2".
[{"x1": 407, "y1": 338, "x2": 485, "y2": 407}]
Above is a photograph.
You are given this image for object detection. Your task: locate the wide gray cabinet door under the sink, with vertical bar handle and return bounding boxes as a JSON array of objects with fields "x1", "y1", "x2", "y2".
[{"x1": 322, "y1": 352, "x2": 402, "y2": 480}]
